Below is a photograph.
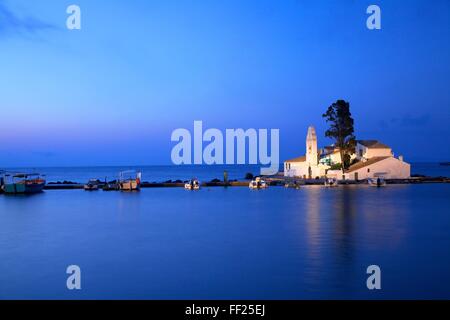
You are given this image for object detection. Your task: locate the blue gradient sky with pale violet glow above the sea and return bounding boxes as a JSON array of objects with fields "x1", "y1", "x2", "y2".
[{"x1": 0, "y1": 0, "x2": 450, "y2": 167}]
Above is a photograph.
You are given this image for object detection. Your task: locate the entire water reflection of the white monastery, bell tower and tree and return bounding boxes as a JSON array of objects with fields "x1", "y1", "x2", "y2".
[{"x1": 299, "y1": 186, "x2": 413, "y2": 294}]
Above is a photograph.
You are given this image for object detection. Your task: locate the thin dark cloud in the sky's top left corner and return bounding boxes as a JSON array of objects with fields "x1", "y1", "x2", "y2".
[{"x1": 0, "y1": 0, "x2": 56, "y2": 36}]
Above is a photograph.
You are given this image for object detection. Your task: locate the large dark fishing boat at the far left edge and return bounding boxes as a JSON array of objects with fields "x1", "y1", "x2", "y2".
[{"x1": 2, "y1": 173, "x2": 45, "y2": 194}]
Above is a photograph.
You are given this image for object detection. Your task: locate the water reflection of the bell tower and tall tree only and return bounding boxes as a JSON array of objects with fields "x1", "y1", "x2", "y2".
[{"x1": 300, "y1": 186, "x2": 357, "y2": 291}]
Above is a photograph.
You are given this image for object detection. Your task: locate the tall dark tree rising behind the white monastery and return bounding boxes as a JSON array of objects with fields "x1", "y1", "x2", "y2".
[{"x1": 322, "y1": 100, "x2": 356, "y2": 173}]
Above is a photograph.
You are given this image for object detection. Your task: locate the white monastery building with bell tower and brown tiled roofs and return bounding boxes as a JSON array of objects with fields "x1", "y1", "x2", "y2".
[{"x1": 284, "y1": 126, "x2": 411, "y2": 180}]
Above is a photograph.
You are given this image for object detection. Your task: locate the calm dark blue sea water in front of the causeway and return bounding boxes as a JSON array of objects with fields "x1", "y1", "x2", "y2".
[{"x1": 0, "y1": 164, "x2": 450, "y2": 299}]
